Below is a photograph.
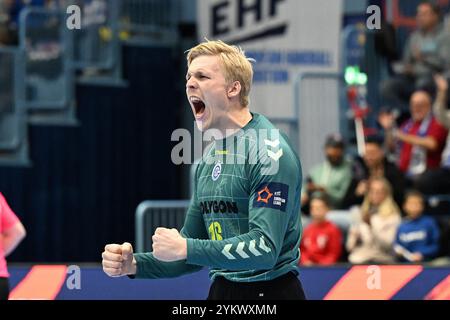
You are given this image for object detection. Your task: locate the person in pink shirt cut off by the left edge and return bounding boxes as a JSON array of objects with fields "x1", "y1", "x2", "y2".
[{"x1": 0, "y1": 193, "x2": 26, "y2": 300}]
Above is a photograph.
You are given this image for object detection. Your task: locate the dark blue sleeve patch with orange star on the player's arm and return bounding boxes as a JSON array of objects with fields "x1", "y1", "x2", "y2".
[{"x1": 253, "y1": 182, "x2": 289, "y2": 212}]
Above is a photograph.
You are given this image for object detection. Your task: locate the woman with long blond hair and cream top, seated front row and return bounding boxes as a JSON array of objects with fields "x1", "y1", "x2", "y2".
[{"x1": 346, "y1": 178, "x2": 401, "y2": 264}]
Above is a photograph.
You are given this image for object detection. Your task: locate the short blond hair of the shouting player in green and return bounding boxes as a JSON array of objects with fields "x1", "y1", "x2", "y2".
[{"x1": 187, "y1": 40, "x2": 253, "y2": 107}]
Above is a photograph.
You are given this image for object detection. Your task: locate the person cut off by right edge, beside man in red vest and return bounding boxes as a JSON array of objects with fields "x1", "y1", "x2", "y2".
[{"x1": 417, "y1": 76, "x2": 450, "y2": 194}]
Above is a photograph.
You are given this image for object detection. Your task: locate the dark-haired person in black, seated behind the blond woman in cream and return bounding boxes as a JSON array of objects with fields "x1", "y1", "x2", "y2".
[{"x1": 348, "y1": 136, "x2": 406, "y2": 207}]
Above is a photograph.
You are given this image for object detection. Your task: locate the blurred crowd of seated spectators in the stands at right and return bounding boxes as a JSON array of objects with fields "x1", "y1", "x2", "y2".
[{"x1": 300, "y1": 2, "x2": 450, "y2": 265}]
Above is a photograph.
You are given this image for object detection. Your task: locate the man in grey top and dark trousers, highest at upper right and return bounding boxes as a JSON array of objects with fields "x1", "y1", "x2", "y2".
[{"x1": 380, "y1": 2, "x2": 450, "y2": 111}]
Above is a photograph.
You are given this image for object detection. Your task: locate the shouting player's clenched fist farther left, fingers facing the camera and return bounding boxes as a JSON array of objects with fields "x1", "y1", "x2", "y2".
[{"x1": 102, "y1": 242, "x2": 136, "y2": 277}]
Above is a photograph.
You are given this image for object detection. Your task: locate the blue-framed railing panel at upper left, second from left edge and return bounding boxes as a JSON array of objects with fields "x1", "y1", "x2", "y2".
[{"x1": 18, "y1": 7, "x2": 76, "y2": 123}]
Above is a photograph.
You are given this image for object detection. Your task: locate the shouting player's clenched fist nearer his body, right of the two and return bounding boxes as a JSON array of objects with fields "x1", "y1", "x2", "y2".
[{"x1": 152, "y1": 228, "x2": 187, "y2": 262}]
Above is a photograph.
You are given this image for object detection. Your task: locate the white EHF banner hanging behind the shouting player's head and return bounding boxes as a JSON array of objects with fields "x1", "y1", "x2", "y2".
[{"x1": 197, "y1": 0, "x2": 342, "y2": 118}]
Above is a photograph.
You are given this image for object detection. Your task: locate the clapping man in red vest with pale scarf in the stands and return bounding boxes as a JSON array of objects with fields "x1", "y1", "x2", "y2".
[{"x1": 378, "y1": 91, "x2": 448, "y2": 183}]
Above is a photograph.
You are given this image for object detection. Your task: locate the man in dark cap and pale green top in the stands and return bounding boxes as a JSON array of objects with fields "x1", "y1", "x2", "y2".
[{"x1": 301, "y1": 134, "x2": 352, "y2": 212}]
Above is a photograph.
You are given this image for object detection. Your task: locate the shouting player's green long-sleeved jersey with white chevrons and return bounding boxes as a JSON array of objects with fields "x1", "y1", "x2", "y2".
[{"x1": 135, "y1": 113, "x2": 302, "y2": 282}]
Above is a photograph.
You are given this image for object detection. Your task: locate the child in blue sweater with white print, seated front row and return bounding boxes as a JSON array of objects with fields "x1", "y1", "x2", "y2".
[{"x1": 394, "y1": 191, "x2": 439, "y2": 262}]
